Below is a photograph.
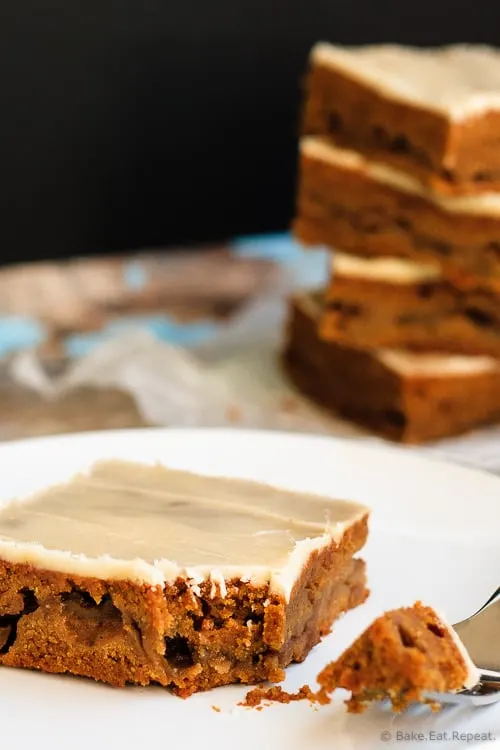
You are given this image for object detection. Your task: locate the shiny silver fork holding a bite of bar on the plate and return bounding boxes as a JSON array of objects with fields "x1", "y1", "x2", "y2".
[{"x1": 432, "y1": 587, "x2": 500, "y2": 706}]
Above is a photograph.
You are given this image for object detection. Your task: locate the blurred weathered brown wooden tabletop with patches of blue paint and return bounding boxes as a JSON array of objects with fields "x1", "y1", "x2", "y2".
[{"x1": 0, "y1": 235, "x2": 322, "y2": 440}]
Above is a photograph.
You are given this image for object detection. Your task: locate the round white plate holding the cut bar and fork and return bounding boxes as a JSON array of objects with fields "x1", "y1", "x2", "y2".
[{"x1": 0, "y1": 430, "x2": 500, "y2": 750}]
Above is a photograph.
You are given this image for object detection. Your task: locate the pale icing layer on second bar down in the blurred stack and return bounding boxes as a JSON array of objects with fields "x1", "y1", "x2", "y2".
[{"x1": 300, "y1": 136, "x2": 500, "y2": 217}]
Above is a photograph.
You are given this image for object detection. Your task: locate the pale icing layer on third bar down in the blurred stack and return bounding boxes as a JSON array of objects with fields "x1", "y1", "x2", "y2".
[{"x1": 332, "y1": 250, "x2": 441, "y2": 284}]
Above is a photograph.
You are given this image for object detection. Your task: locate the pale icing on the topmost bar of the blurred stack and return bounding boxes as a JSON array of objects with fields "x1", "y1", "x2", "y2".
[{"x1": 311, "y1": 42, "x2": 500, "y2": 121}]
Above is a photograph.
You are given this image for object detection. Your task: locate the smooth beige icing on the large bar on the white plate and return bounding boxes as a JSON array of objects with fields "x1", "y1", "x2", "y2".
[{"x1": 0, "y1": 461, "x2": 368, "y2": 597}]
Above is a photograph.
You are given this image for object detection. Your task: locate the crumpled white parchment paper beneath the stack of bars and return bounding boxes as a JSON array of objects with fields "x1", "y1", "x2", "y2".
[{"x1": 9, "y1": 289, "x2": 500, "y2": 473}]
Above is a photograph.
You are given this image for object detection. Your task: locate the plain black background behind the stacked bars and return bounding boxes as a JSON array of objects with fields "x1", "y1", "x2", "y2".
[{"x1": 0, "y1": 0, "x2": 500, "y2": 261}]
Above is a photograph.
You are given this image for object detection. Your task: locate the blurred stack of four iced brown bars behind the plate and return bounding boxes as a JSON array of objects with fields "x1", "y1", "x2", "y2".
[{"x1": 285, "y1": 44, "x2": 500, "y2": 443}]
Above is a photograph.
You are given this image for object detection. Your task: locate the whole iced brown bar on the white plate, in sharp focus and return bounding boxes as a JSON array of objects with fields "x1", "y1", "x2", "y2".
[{"x1": 0, "y1": 461, "x2": 369, "y2": 697}]
